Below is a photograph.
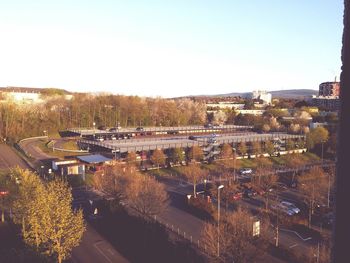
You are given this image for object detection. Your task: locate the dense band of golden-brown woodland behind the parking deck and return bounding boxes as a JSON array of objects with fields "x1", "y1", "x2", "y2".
[{"x1": 0, "y1": 93, "x2": 206, "y2": 140}]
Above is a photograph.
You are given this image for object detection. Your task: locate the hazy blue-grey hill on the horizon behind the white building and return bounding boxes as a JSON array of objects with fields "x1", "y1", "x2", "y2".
[{"x1": 191, "y1": 89, "x2": 318, "y2": 99}]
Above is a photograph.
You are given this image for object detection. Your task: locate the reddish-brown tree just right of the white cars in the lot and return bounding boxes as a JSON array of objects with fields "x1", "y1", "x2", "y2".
[{"x1": 299, "y1": 167, "x2": 328, "y2": 227}]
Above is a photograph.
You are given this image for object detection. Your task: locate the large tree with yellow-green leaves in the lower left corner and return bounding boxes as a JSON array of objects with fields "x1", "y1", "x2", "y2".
[{"x1": 11, "y1": 168, "x2": 85, "y2": 263}]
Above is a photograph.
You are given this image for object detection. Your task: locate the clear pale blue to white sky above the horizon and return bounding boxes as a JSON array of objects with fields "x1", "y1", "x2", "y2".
[{"x1": 0, "y1": 0, "x2": 343, "y2": 97}]
